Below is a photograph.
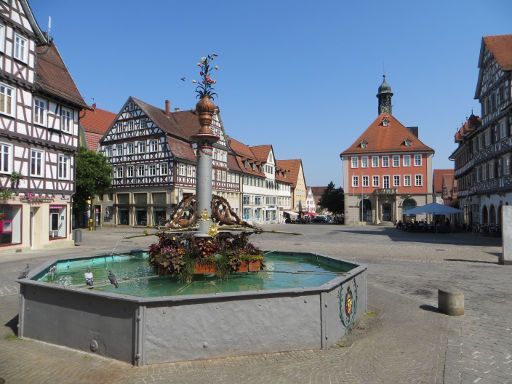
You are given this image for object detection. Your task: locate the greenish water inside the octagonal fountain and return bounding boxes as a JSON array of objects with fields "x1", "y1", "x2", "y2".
[{"x1": 35, "y1": 252, "x2": 356, "y2": 297}]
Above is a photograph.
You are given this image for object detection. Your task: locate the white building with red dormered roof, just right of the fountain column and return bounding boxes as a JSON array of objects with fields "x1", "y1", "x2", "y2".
[{"x1": 229, "y1": 138, "x2": 292, "y2": 224}]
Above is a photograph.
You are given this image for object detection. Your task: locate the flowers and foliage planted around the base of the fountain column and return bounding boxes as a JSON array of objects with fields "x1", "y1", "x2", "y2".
[{"x1": 149, "y1": 232, "x2": 263, "y2": 282}]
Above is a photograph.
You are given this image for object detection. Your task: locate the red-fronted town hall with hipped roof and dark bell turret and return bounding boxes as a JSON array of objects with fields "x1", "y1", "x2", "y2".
[{"x1": 340, "y1": 78, "x2": 434, "y2": 224}]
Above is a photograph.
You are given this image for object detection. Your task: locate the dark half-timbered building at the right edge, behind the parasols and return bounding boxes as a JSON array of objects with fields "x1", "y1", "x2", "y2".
[{"x1": 450, "y1": 35, "x2": 512, "y2": 228}]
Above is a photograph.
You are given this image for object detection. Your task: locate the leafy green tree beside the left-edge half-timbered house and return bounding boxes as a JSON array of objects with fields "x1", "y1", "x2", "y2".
[{"x1": 73, "y1": 148, "x2": 112, "y2": 222}]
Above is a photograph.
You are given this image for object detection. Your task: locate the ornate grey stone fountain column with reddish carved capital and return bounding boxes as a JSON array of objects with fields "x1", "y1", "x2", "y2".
[{"x1": 192, "y1": 96, "x2": 219, "y2": 237}]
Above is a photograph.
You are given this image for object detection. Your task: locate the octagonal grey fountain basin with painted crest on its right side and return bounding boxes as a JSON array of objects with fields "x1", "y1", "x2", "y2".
[{"x1": 18, "y1": 253, "x2": 367, "y2": 365}]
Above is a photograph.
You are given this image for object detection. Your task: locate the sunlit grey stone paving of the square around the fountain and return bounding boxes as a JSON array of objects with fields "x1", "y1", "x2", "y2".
[{"x1": 0, "y1": 225, "x2": 512, "y2": 384}]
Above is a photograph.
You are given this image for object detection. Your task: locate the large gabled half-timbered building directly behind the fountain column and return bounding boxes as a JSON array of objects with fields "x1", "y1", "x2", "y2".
[{"x1": 100, "y1": 97, "x2": 241, "y2": 226}]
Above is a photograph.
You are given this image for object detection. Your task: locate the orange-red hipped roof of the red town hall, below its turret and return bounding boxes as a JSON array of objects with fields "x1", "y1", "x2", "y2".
[{"x1": 341, "y1": 113, "x2": 434, "y2": 155}]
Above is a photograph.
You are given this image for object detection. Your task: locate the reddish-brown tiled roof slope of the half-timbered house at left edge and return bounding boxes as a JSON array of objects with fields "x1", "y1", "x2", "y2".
[{"x1": 36, "y1": 43, "x2": 87, "y2": 108}]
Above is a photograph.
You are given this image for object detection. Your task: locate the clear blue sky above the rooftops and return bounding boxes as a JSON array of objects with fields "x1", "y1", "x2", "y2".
[{"x1": 31, "y1": 0, "x2": 512, "y2": 186}]
